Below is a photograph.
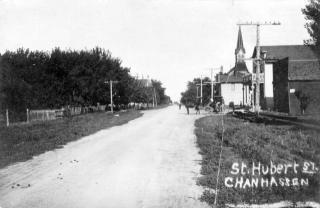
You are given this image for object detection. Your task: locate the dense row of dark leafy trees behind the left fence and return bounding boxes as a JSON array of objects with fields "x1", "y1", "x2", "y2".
[{"x1": 0, "y1": 48, "x2": 170, "y2": 112}]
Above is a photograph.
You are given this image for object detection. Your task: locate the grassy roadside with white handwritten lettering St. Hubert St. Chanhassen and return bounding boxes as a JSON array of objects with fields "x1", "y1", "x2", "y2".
[{"x1": 195, "y1": 115, "x2": 320, "y2": 206}]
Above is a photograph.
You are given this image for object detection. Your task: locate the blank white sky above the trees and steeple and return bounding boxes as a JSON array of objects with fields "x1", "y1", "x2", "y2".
[{"x1": 0, "y1": 0, "x2": 309, "y2": 100}]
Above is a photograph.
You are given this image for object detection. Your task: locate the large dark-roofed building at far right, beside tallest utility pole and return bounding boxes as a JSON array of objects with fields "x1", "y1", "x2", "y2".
[{"x1": 252, "y1": 45, "x2": 320, "y2": 115}]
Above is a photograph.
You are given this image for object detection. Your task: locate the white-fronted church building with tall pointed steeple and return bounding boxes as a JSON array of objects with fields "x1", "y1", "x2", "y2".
[{"x1": 216, "y1": 27, "x2": 250, "y2": 105}]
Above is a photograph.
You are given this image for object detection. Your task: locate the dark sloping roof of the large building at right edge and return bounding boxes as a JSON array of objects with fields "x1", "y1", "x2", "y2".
[{"x1": 252, "y1": 45, "x2": 320, "y2": 80}]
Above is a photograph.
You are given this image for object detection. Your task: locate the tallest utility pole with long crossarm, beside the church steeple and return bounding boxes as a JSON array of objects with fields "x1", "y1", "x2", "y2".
[{"x1": 237, "y1": 22, "x2": 280, "y2": 115}]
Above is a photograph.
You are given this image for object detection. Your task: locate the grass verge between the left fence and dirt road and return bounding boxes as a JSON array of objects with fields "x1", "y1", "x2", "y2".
[{"x1": 0, "y1": 110, "x2": 142, "y2": 168}]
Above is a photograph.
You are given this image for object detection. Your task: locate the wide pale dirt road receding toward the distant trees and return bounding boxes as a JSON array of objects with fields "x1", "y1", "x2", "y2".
[{"x1": 0, "y1": 106, "x2": 207, "y2": 208}]
